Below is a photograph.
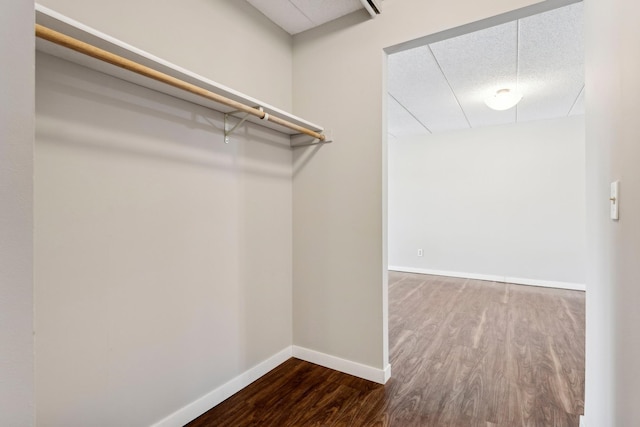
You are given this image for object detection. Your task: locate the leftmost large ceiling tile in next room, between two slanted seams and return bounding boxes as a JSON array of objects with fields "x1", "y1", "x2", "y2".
[{"x1": 387, "y1": 46, "x2": 469, "y2": 133}]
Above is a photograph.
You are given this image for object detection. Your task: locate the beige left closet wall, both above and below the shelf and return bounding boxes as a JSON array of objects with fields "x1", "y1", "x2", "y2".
[{"x1": 35, "y1": 0, "x2": 292, "y2": 426}]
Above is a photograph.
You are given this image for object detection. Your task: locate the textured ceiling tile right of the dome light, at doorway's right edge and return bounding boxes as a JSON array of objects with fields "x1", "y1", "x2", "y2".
[{"x1": 518, "y1": 2, "x2": 584, "y2": 121}]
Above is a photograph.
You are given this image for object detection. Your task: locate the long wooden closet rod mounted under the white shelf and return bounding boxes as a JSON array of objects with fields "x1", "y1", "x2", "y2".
[{"x1": 36, "y1": 24, "x2": 326, "y2": 141}]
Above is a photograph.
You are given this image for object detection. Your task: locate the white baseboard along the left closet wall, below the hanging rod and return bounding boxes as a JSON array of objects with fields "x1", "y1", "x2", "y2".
[{"x1": 152, "y1": 347, "x2": 292, "y2": 427}]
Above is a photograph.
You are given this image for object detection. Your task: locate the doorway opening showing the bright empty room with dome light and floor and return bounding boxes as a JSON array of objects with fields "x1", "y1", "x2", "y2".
[{"x1": 386, "y1": 1, "x2": 586, "y2": 426}]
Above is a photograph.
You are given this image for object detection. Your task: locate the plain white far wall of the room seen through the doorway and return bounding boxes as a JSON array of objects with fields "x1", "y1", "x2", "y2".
[{"x1": 389, "y1": 116, "x2": 586, "y2": 285}]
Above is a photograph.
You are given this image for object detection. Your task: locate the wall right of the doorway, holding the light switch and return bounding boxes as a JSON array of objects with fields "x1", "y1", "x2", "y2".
[{"x1": 585, "y1": 0, "x2": 640, "y2": 427}]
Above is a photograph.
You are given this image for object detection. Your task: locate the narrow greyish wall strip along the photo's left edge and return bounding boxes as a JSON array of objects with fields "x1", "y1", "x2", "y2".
[{"x1": 0, "y1": 1, "x2": 34, "y2": 427}]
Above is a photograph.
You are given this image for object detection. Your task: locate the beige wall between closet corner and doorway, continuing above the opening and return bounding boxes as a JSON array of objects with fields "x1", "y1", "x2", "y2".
[{"x1": 293, "y1": 0, "x2": 535, "y2": 368}]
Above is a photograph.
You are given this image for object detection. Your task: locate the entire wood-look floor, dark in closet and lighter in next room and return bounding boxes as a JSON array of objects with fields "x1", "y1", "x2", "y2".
[{"x1": 188, "y1": 272, "x2": 585, "y2": 427}]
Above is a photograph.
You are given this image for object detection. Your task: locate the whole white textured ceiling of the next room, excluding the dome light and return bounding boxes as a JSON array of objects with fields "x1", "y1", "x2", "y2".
[{"x1": 388, "y1": 2, "x2": 584, "y2": 136}]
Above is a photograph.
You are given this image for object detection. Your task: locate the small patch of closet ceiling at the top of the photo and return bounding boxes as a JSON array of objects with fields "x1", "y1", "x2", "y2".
[{"x1": 247, "y1": 0, "x2": 364, "y2": 35}]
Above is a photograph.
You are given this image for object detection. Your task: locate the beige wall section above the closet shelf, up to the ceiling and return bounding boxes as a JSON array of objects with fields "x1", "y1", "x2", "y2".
[{"x1": 38, "y1": 0, "x2": 292, "y2": 111}]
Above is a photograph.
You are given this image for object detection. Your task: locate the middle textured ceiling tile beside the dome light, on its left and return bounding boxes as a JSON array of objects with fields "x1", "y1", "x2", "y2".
[{"x1": 431, "y1": 21, "x2": 517, "y2": 127}]
